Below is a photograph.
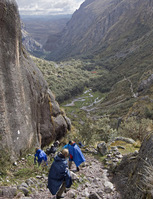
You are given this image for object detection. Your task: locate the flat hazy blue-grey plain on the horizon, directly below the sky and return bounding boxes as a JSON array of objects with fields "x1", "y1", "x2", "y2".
[{"x1": 21, "y1": 15, "x2": 71, "y2": 45}]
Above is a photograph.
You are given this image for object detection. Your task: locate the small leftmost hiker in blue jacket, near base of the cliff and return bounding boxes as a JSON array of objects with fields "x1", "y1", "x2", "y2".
[{"x1": 34, "y1": 148, "x2": 48, "y2": 166}]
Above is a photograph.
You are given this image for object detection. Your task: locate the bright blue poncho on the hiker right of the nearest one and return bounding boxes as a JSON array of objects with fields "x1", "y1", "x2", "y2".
[{"x1": 68, "y1": 143, "x2": 86, "y2": 167}]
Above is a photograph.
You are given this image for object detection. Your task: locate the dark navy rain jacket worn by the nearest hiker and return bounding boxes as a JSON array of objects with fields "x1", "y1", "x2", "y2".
[{"x1": 48, "y1": 154, "x2": 72, "y2": 195}]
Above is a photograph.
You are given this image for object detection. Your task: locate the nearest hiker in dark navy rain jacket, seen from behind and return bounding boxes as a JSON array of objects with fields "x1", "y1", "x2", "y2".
[{"x1": 48, "y1": 149, "x2": 72, "y2": 199}]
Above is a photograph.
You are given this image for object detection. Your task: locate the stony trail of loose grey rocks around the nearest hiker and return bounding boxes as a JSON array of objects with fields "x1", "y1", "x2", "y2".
[{"x1": 0, "y1": 154, "x2": 122, "y2": 199}]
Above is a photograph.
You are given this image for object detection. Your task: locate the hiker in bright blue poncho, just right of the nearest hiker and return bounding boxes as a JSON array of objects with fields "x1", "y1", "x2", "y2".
[{"x1": 68, "y1": 141, "x2": 86, "y2": 171}]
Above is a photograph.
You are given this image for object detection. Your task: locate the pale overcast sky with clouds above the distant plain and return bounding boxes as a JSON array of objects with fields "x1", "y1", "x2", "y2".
[{"x1": 16, "y1": 0, "x2": 85, "y2": 15}]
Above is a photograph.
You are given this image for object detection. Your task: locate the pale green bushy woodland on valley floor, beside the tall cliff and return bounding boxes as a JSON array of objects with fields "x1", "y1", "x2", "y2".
[{"x1": 33, "y1": 57, "x2": 101, "y2": 102}]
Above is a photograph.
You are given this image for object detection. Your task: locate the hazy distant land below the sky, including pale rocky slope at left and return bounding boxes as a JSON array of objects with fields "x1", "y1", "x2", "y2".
[{"x1": 21, "y1": 15, "x2": 71, "y2": 57}]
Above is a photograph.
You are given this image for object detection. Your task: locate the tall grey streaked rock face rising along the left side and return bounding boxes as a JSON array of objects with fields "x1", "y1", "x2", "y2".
[{"x1": 0, "y1": 0, "x2": 70, "y2": 159}]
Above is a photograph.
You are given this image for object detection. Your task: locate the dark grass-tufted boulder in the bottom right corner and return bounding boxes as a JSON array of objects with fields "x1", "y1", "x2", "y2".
[{"x1": 114, "y1": 133, "x2": 153, "y2": 199}]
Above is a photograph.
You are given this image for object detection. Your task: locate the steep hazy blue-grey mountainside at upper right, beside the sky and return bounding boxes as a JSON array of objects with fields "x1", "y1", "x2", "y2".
[{"x1": 44, "y1": 0, "x2": 153, "y2": 60}]
